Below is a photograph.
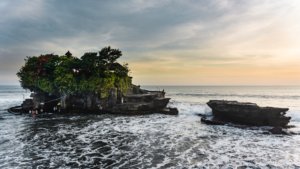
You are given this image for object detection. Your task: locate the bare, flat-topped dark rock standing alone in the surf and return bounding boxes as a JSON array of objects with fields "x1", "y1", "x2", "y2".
[{"x1": 206, "y1": 100, "x2": 291, "y2": 128}]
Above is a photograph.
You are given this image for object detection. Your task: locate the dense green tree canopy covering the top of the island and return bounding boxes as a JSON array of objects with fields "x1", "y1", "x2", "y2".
[{"x1": 17, "y1": 46, "x2": 131, "y2": 96}]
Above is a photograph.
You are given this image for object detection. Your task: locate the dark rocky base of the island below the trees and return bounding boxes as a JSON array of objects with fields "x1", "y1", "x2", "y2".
[{"x1": 22, "y1": 85, "x2": 178, "y2": 114}]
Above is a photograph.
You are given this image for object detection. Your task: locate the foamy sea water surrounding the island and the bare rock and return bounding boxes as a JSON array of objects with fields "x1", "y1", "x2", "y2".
[{"x1": 0, "y1": 86, "x2": 300, "y2": 169}]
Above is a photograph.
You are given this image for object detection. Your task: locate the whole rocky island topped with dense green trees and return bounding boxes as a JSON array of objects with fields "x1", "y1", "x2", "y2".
[{"x1": 9, "y1": 46, "x2": 178, "y2": 114}]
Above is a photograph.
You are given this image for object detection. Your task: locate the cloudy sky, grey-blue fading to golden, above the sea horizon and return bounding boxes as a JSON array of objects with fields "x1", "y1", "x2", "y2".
[{"x1": 0, "y1": 0, "x2": 300, "y2": 85}]
